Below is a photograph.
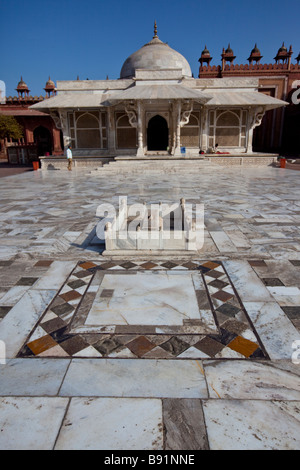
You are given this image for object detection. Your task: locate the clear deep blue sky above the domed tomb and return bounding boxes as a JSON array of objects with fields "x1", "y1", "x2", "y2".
[{"x1": 0, "y1": 0, "x2": 300, "y2": 96}]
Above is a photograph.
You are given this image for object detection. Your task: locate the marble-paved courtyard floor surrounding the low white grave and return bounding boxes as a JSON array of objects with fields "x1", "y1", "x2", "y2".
[{"x1": 0, "y1": 165, "x2": 300, "y2": 451}]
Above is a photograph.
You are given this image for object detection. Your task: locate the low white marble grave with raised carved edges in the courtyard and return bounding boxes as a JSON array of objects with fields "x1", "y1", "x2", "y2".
[{"x1": 103, "y1": 199, "x2": 204, "y2": 255}]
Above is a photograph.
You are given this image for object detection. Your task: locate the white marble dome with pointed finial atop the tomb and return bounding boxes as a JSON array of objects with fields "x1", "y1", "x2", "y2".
[{"x1": 120, "y1": 29, "x2": 192, "y2": 78}]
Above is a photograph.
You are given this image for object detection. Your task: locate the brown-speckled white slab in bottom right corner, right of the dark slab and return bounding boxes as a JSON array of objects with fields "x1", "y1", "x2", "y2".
[{"x1": 204, "y1": 400, "x2": 300, "y2": 450}]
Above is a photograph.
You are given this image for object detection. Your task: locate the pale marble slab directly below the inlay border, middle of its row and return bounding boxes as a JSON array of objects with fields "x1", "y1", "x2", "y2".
[{"x1": 60, "y1": 359, "x2": 207, "y2": 398}]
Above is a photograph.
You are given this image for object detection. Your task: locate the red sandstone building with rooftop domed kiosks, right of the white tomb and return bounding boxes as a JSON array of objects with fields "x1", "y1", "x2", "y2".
[{"x1": 199, "y1": 43, "x2": 300, "y2": 155}]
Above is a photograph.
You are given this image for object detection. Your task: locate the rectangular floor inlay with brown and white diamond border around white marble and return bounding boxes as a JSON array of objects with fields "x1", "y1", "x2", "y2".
[{"x1": 18, "y1": 261, "x2": 268, "y2": 359}]
